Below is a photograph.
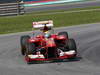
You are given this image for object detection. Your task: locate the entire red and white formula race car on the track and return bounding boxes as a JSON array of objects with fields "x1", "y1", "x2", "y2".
[{"x1": 20, "y1": 20, "x2": 77, "y2": 63}]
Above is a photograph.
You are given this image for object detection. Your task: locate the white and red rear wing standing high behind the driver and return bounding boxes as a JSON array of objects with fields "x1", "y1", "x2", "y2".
[{"x1": 33, "y1": 20, "x2": 53, "y2": 28}]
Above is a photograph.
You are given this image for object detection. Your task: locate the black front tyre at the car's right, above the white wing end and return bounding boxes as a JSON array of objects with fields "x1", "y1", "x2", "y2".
[{"x1": 67, "y1": 39, "x2": 77, "y2": 56}]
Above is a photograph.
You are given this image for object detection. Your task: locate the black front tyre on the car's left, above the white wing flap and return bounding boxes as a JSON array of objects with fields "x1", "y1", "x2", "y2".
[{"x1": 26, "y1": 42, "x2": 36, "y2": 55}]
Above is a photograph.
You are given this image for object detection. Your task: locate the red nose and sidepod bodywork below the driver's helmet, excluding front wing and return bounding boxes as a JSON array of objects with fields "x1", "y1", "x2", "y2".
[{"x1": 28, "y1": 34, "x2": 67, "y2": 47}]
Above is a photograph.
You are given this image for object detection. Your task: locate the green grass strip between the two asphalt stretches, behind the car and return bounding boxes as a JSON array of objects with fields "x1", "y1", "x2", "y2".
[{"x1": 0, "y1": 7, "x2": 100, "y2": 34}]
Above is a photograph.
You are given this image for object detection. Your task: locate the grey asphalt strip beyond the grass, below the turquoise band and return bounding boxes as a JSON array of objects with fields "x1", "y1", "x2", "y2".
[{"x1": 25, "y1": 0, "x2": 100, "y2": 13}]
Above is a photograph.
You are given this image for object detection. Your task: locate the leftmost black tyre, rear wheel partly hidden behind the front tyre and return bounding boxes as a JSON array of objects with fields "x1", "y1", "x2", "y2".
[{"x1": 20, "y1": 35, "x2": 30, "y2": 55}]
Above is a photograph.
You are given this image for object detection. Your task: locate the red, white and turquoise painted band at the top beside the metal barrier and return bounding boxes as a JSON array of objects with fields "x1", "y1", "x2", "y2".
[{"x1": 24, "y1": 0, "x2": 84, "y2": 7}]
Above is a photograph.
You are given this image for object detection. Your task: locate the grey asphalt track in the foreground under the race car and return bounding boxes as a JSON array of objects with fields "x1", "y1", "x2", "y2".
[{"x1": 0, "y1": 23, "x2": 100, "y2": 75}]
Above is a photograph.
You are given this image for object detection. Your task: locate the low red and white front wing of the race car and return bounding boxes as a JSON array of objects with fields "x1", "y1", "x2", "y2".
[{"x1": 25, "y1": 50, "x2": 76, "y2": 62}]
